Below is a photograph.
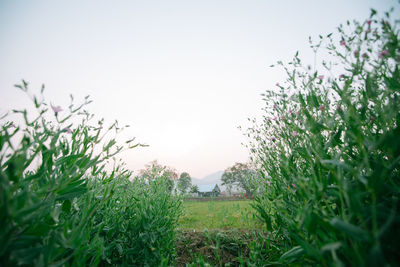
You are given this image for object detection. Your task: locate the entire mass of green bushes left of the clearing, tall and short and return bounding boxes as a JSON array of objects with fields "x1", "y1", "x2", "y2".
[{"x1": 0, "y1": 81, "x2": 180, "y2": 266}]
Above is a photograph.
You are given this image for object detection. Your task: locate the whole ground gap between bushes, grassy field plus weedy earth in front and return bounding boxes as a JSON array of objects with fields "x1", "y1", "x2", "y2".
[{"x1": 175, "y1": 199, "x2": 261, "y2": 266}]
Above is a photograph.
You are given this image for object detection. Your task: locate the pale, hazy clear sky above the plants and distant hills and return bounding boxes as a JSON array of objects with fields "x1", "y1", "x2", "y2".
[{"x1": 0, "y1": 0, "x2": 400, "y2": 178}]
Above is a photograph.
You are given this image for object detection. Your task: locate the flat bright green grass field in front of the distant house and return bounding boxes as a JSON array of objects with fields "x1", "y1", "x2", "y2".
[{"x1": 179, "y1": 200, "x2": 260, "y2": 230}]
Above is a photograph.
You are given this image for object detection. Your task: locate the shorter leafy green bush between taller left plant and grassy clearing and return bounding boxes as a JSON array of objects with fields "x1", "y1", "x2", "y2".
[{"x1": 95, "y1": 178, "x2": 181, "y2": 266}]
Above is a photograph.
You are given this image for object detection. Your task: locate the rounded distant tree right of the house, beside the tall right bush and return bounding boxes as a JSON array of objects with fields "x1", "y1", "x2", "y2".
[{"x1": 221, "y1": 163, "x2": 258, "y2": 196}]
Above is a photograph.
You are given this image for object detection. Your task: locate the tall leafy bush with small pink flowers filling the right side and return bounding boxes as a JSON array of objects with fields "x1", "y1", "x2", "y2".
[{"x1": 249, "y1": 10, "x2": 400, "y2": 266}]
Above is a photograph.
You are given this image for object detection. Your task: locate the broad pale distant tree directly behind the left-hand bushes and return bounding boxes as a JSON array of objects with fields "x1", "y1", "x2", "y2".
[{"x1": 139, "y1": 160, "x2": 178, "y2": 192}]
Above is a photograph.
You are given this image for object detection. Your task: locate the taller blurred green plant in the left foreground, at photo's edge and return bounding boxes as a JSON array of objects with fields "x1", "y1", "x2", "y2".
[{"x1": 0, "y1": 81, "x2": 118, "y2": 265}]
